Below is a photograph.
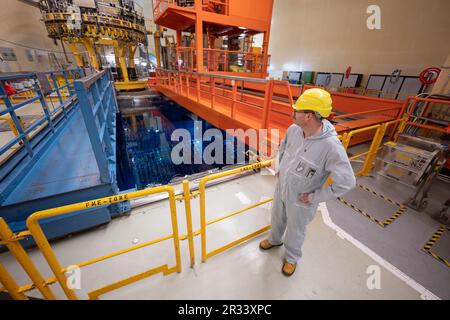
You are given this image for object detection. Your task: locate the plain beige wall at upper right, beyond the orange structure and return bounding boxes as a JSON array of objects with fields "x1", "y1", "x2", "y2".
[{"x1": 269, "y1": 0, "x2": 450, "y2": 84}]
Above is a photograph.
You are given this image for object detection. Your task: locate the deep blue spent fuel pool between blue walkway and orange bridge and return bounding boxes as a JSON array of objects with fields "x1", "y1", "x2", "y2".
[{"x1": 117, "y1": 95, "x2": 253, "y2": 190}]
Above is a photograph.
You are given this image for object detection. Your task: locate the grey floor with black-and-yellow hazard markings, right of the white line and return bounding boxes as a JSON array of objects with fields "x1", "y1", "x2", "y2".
[{"x1": 327, "y1": 145, "x2": 450, "y2": 299}]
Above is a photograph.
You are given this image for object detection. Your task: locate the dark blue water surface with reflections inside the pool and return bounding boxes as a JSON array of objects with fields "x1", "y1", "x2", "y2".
[{"x1": 118, "y1": 97, "x2": 248, "y2": 190}]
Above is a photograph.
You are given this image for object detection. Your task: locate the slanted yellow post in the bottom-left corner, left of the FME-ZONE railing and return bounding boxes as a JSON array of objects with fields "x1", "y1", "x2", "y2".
[{"x1": 0, "y1": 218, "x2": 56, "y2": 300}]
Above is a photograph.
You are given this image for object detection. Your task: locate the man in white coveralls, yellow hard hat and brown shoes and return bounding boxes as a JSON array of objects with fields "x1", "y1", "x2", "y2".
[{"x1": 259, "y1": 88, "x2": 356, "y2": 276}]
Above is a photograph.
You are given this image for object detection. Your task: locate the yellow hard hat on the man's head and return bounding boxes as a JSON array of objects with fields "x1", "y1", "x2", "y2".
[{"x1": 292, "y1": 88, "x2": 332, "y2": 118}]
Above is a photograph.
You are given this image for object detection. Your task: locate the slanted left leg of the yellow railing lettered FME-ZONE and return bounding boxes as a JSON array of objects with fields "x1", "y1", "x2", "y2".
[{"x1": 27, "y1": 215, "x2": 78, "y2": 300}]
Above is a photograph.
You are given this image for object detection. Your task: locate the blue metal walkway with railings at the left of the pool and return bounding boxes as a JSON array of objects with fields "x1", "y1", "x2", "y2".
[{"x1": 0, "y1": 69, "x2": 130, "y2": 245}]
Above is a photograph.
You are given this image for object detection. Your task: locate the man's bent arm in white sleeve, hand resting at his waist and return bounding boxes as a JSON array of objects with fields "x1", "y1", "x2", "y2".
[{"x1": 310, "y1": 146, "x2": 356, "y2": 203}]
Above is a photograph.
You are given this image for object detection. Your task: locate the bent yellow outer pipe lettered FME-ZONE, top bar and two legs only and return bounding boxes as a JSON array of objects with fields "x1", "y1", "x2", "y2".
[{"x1": 26, "y1": 186, "x2": 181, "y2": 299}]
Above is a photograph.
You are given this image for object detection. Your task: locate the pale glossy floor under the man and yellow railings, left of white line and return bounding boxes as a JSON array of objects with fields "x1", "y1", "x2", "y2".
[{"x1": 0, "y1": 174, "x2": 422, "y2": 299}]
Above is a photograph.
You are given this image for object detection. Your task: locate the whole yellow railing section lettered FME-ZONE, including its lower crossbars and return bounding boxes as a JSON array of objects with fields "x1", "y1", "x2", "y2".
[{"x1": 20, "y1": 186, "x2": 181, "y2": 300}]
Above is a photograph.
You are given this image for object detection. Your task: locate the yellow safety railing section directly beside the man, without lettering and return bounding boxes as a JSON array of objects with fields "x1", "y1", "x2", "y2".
[{"x1": 199, "y1": 160, "x2": 274, "y2": 262}]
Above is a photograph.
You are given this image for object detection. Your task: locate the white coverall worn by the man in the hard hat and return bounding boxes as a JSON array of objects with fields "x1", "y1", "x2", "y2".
[{"x1": 268, "y1": 120, "x2": 356, "y2": 264}]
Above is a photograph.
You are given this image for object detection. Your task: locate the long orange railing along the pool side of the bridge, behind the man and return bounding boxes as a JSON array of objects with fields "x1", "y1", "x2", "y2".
[{"x1": 156, "y1": 69, "x2": 292, "y2": 138}]
